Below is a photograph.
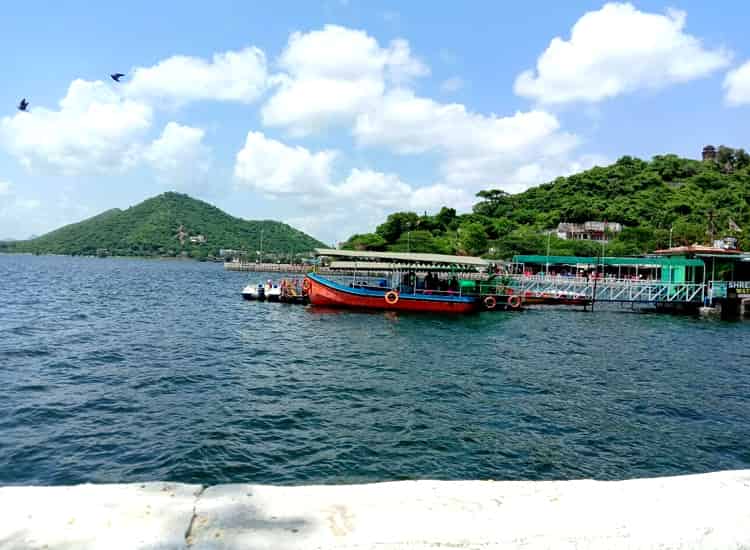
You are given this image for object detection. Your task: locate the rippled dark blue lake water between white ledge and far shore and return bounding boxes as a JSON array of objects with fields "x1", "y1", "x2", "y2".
[{"x1": 0, "y1": 255, "x2": 750, "y2": 484}]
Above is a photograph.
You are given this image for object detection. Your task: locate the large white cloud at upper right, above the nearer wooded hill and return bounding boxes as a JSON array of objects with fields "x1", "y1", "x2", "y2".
[{"x1": 515, "y1": 3, "x2": 730, "y2": 103}]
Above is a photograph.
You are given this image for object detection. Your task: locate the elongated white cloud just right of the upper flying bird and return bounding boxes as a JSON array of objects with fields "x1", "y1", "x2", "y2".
[{"x1": 124, "y1": 48, "x2": 268, "y2": 105}]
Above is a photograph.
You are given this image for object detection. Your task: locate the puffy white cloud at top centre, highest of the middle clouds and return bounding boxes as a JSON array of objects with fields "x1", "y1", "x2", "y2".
[{"x1": 262, "y1": 25, "x2": 429, "y2": 136}]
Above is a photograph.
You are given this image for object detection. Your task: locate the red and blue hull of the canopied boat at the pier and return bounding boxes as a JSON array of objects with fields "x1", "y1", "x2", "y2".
[{"x1": 304, "y1": 273, "x2": 481, "y2": 313}]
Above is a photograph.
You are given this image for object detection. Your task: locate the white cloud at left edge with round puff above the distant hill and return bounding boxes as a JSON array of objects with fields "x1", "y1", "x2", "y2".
[{"x1": 0, "y1": 80, "x2": 220, "y2": 189}]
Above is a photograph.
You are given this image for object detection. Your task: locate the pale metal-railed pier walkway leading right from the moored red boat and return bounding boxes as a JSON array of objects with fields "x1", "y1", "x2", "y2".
[{"x1": 510, "y1": 275, "x2": 706, "y2": 304}]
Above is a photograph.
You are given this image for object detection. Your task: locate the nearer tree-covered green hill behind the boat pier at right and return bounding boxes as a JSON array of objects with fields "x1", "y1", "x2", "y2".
[{"x1": 344, "y1": 147, "x2": 750, "y2": 258}]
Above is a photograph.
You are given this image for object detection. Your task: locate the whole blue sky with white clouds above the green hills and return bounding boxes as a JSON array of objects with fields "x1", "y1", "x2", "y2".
[{"x1": 0, "y1": 0, "x2": 750, "y2": 244}]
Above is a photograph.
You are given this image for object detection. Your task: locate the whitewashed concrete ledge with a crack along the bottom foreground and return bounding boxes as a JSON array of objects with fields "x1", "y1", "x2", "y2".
[{"x1": 0, "y1": 470, "x2": 750, "y2": 550}]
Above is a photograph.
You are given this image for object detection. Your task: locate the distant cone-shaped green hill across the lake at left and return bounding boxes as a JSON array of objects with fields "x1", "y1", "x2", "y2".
[{"x1": 0, "y1": 193, "x2": 325, "y2": 258}]
